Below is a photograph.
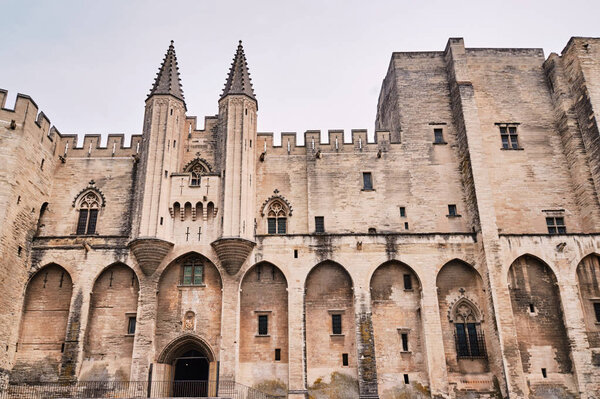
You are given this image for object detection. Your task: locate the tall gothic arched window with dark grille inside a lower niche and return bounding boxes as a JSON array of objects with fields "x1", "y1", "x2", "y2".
[{"x1": 453, "y1": 300, "x2": 487, "y2": 359}]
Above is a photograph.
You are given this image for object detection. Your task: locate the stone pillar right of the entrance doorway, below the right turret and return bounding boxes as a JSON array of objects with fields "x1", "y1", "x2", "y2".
[{"x1": 219, "y1": 274, "x2": 240, "y2": 381}]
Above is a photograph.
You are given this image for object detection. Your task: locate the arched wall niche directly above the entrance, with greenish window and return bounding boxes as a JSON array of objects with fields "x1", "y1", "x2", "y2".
[{"x1": 155, "y1": 252, "x2": 222, "y2": 370}]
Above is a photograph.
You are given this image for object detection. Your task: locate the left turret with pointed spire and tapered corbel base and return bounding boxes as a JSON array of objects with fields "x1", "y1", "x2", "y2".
[{"x1": 130, "y1": 41, "x2": 186, "y2": 272}]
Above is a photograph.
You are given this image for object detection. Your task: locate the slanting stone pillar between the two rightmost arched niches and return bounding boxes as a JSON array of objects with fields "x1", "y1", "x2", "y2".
[{"x1": 559, "y1": 278, "x2": 600, "y2": 399}]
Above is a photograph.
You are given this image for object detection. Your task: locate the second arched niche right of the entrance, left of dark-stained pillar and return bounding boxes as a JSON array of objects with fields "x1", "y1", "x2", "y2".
[{"x1": 305, "y1": 261, "x2": 358, "y2": 394}]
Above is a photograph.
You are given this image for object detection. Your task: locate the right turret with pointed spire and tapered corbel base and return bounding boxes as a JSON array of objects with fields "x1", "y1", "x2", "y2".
[{"x1": 213, "y1": 41, "x2": 258, "y2": 273}]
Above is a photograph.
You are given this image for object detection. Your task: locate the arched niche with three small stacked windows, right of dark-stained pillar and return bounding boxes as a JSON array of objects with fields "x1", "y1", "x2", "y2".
[{"x1": 370, "y1": 261, "x2": 429, "y2": 395}]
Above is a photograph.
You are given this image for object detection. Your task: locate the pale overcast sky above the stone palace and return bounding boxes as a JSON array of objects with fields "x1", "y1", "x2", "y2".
[{"x1": 0, "y1": 0, "x2": 600, "y2": 145}]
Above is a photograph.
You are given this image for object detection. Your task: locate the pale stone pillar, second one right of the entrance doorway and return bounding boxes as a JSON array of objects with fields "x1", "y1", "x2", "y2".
[{"x1": 288, "y1": 280, "x2": 308, "y2": 399}]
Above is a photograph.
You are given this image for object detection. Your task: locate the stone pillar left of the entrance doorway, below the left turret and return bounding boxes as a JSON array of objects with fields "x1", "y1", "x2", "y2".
[{"x1": 131, "y1": 275, "x2": 158, "y2": 381}]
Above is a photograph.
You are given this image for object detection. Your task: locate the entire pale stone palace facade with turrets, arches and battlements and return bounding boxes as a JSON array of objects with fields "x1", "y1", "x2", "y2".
[{"x1": 0, "y1": 38, "x2": 600, "y2": 399}]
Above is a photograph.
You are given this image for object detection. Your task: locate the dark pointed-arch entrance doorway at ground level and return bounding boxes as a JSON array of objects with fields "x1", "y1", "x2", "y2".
[{"x1": 153, "y1": 334, "x2": 217, "y2": 397}]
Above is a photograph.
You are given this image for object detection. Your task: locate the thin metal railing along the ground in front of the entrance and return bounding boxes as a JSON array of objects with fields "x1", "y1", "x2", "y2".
[{"x1": 0, "y1": 381, "x2": 282, "y2": 399}]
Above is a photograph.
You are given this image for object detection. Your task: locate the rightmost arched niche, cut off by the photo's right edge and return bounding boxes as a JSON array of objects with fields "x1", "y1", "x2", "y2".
[{"x1": 577, "y1": 253, "x2": 600, "y2": 348}]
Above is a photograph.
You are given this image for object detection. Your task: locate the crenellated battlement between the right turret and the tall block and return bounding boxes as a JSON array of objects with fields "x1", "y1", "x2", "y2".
[{"x1": 257, "y1": 129, "x2": 400, "y2": 155}]
